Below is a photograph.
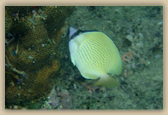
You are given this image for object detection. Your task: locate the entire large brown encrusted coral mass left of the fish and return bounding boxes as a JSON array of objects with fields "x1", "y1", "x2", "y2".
[{"x1": 5, "y1": 6, "x2": 73, "y2": 106}]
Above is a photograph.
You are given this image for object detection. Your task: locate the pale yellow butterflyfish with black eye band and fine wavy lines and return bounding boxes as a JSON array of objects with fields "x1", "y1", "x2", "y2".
[{"x1": 69, "y1": 27, "x2": 122, "y2": 87}]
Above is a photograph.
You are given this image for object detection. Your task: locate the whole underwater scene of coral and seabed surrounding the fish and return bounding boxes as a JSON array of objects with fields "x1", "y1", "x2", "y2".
[{"x1": 5, "y1": 6, "x2": 163, "y2": 110}]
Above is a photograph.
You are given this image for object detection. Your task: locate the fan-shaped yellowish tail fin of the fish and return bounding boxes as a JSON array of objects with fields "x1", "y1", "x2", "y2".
[{"x1": 94, "y1": 75, "x2": 120, "y2": 87}]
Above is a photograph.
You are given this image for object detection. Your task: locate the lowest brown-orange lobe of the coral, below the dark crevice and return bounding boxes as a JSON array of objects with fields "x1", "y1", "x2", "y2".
[{"x1": 5, "y1": 60, "x2": 60, "y2": 103}]
